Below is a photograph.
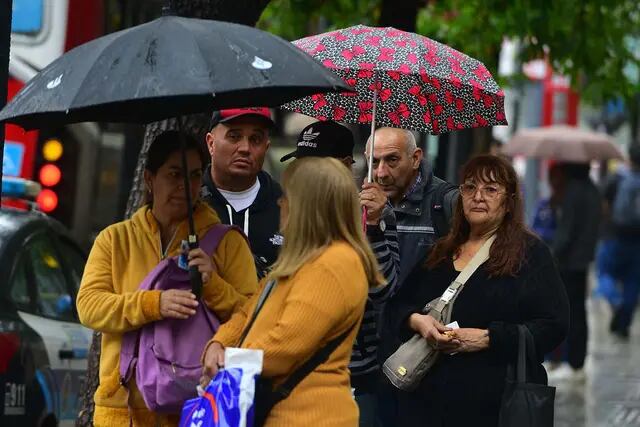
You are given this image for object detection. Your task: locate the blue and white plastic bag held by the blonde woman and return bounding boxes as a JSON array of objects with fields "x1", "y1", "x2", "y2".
[{"x1": 180, "y1": 348, "x2": 263, "y2": 427}]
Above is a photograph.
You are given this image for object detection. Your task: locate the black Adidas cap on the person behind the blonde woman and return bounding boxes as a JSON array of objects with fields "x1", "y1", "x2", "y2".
[{"x1": 280, "y1": 121, "x2": 354, "y2": 162}]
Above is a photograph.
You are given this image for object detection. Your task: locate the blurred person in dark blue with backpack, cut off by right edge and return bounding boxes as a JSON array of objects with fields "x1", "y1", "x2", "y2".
[{"x1": 608, "y1": 144, "x2": 640, "y2": 339}]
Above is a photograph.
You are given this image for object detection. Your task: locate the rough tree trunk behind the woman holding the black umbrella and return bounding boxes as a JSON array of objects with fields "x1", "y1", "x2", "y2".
[{"x1": 76, "y1": 0, "x2": 270, "y2": 427}]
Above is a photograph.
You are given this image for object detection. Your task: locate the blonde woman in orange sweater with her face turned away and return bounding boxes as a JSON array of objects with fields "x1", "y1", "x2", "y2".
[{"x1": 204, "y1": 157, "x2": 382, "y2": 427}]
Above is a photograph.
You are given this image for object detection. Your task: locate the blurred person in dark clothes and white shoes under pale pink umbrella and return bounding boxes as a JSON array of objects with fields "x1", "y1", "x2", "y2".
[{"x1": 550, "y1": 163, "x2": 602, "y2": 381}]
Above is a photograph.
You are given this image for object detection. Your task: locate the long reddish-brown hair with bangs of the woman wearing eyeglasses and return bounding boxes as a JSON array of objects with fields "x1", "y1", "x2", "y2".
[{"x1": 426, "y1": 155, "x2": 534, "y2": 276}]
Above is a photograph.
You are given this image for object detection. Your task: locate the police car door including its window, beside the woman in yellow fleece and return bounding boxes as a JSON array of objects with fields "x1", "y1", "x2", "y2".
[{"x1": 19, "y1": 232, "x2": 91, "y2": 426}]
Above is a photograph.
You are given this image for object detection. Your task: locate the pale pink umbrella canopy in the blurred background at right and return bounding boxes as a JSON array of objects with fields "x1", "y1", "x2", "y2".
[{"x1": 503, "y1": 126, "x2": 624, "y2": 163}]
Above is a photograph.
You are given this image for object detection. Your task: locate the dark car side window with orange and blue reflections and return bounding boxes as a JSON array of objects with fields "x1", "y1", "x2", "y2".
[{"x1": 27, "y1": 234, "x2": 75, "y2": 321}]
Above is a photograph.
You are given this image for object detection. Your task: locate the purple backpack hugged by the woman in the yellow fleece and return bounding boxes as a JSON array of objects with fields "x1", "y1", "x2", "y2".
[{"x1": 120, "y1": 224, "x2": 235, "y2": 414}]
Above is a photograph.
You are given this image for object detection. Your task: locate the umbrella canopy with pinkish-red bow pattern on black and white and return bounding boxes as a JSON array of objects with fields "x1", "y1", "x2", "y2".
[{"x1": 283, "y1": 25, "x2": 507, "y2": 135}]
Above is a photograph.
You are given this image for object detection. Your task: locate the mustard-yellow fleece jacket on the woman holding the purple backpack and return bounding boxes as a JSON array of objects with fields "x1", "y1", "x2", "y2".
[{"x1": 77, "y1": 203, "x2": 257, "y2": 427}]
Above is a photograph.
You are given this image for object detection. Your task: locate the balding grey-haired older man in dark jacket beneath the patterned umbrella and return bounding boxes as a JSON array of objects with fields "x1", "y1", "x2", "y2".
[{"x1": 365, "y1": 128, "x2": 458, "y2": 427}]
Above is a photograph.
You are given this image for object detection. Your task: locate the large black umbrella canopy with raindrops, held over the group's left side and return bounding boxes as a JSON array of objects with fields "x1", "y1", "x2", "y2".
[{"x1": 0, "y1": 16, "x2": 349, "y2": 128}]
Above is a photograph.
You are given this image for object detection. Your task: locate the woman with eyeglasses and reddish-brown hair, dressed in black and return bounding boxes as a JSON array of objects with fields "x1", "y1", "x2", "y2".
[{"x1": 387, "y1": 156, "x2": 569, "y2": 427}]
